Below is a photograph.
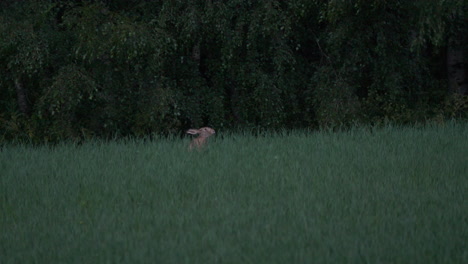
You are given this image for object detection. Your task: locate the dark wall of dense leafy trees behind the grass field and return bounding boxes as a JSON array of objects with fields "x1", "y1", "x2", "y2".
[{"x1": 0, "y1": 0, "x2": 468, "y2": 142}]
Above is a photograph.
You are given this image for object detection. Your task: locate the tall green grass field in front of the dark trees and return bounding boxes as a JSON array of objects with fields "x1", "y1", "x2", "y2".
[{"x1": 0, "y1": 123, "x2": 468, "y2": 264}]
